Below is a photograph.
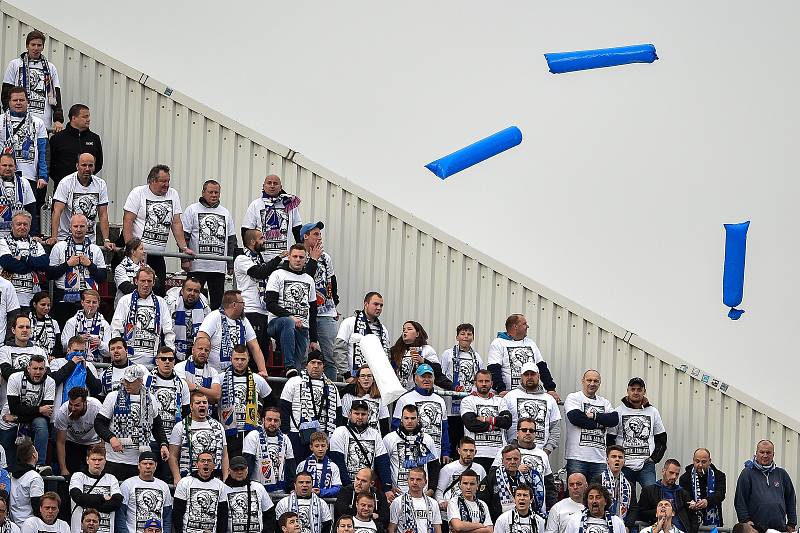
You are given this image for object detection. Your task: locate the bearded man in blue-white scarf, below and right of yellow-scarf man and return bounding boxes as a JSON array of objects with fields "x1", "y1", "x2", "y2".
[{"x1": 242, "y1": 407, "x2": 296, "y2": 492}]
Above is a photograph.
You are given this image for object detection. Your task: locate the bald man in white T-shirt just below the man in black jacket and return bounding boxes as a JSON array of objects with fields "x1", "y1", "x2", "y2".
[{"x1": 47, "y1": 153, "x2": 114, "y2": 246}]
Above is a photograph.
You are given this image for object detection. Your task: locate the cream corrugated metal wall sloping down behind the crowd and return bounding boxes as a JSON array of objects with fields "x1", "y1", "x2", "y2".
[{"x1": 0, "y1": 3, "x2": 800, "y2": 523}]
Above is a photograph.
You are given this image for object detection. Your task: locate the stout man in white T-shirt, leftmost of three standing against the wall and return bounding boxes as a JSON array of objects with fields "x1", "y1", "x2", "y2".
[{"x1": 121, "y1": 165, "x2": 194, "y2": 296}]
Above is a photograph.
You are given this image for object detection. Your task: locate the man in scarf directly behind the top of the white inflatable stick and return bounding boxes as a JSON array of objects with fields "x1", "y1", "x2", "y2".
[{"x1": 333, "y1": 291, "x2": 389, "y2": 381}]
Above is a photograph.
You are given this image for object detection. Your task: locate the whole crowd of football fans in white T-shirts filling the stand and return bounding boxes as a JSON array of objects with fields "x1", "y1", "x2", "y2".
[{"x1": 0, "y1": 30, "x2": 797, "y2": 533}]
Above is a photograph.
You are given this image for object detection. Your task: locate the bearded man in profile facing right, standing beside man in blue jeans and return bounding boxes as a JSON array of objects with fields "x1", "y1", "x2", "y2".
[{"x1": 233, "y1": 229, "x2": 289, "y2": 353}]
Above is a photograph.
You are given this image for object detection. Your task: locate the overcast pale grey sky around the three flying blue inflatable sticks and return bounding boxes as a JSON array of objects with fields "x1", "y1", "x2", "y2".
[{"x1": 12, "y1": 0, "x2": 800, "y2": 415}]
